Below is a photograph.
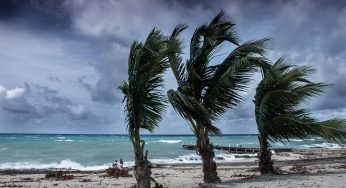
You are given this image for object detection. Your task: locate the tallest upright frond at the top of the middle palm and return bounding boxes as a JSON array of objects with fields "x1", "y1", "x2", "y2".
[{"x1": 186, "y1": 11, "x2": 239, "y2": 98}]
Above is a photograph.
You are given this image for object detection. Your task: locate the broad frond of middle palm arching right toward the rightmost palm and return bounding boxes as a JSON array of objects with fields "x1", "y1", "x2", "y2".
[{"x1": 204, "y1": 39, "x2": 270, "y2": 118}]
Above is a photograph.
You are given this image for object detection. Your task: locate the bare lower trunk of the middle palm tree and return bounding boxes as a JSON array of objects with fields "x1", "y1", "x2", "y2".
[{"x1": 197, "y1": 131, "x2": 221, "y2": 183}]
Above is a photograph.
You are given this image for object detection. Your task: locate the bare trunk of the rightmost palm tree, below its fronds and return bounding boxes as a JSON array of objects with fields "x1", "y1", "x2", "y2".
[{"x1": 259, "y1": 133, "x2": 274, "y2": 174}]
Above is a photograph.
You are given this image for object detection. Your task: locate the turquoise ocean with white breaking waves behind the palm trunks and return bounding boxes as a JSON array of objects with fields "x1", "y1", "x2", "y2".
[{"x1": 0, "y1": 134, "x2": 345, "y2": 170}]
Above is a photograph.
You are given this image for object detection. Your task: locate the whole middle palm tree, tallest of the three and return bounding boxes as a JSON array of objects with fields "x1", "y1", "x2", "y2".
[{"x1": 168, "y1": 11, "x2": 268, "y2": 182}]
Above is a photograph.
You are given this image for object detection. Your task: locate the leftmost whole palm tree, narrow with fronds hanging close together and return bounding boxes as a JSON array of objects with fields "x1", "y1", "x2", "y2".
[{"x1": 119, "y1": 29, "x2": 169, "y2": 188}]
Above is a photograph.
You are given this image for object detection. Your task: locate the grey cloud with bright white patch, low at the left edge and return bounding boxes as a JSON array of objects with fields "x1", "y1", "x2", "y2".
[{"x1": 0, "y1": 83, "x2": 102, "y2": 121}]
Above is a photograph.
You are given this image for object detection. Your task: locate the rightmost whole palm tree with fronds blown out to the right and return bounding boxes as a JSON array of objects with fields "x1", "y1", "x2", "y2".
[{"x1": 254, "y1": 58, "x2": 346, "y2": 174}]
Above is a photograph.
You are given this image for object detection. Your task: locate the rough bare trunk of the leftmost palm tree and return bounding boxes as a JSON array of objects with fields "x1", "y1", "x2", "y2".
[{"x1": 133, "y1": 141, "x2": 152, "y2": 188}]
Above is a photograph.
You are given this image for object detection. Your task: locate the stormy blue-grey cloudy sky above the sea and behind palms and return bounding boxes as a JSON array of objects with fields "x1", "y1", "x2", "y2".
[{"x1": 0, "y1": 0, "x2": 346, "y2": 134}]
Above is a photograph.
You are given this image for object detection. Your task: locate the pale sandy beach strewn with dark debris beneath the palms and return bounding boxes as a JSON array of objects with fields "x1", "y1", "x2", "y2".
[{"x1": 0, "y1": 149, "x2": 346, "y2": 187}]
